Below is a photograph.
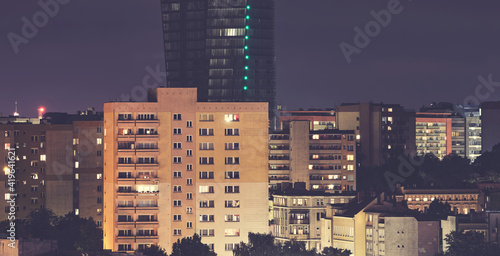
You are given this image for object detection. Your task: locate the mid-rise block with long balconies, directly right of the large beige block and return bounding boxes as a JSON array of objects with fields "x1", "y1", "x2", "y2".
[{"x1": 269, "y1": 120, "x2": 357, "y2": 192}]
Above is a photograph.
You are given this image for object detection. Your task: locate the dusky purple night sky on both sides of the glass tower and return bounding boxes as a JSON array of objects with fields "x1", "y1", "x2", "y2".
[{"x1": 0, "y1": 0, "x2": 500, "y2": 116}]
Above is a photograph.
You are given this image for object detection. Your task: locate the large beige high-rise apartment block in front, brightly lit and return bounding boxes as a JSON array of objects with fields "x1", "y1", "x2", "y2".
[{"x1": 103, "y1": 88, "x2": 268, "y2": 255}]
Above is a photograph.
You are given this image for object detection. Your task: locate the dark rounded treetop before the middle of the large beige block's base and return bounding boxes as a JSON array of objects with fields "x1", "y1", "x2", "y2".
[{"x1": 170, "y1": 234, "x2": 217, "y2": 256}]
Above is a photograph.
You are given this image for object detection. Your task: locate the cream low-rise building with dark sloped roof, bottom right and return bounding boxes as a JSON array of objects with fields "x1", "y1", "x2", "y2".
[{"x1": 322, "y1": 194, "x2": 439, "y2": 256}]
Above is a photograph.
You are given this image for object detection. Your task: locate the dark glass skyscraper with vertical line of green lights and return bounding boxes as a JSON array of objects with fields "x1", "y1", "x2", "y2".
[{"x1": 161, "y1": 0, "x2": 276, "y2": 112}]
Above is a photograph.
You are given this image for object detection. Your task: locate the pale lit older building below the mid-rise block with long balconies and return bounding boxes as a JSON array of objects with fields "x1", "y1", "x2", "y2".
[{"x1": 272, "y1": 183, "x2": 356, "y2": 251}]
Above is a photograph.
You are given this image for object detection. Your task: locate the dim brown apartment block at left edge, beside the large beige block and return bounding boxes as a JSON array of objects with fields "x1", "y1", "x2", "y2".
[{"x1": 0, "y1": 114, "x2": 103, "y2": 225}]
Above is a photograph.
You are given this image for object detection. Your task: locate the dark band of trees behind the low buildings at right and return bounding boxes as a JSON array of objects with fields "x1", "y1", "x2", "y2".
[{"x1": 357, "y1": 144, "x2": 500, "y2": 192}]
